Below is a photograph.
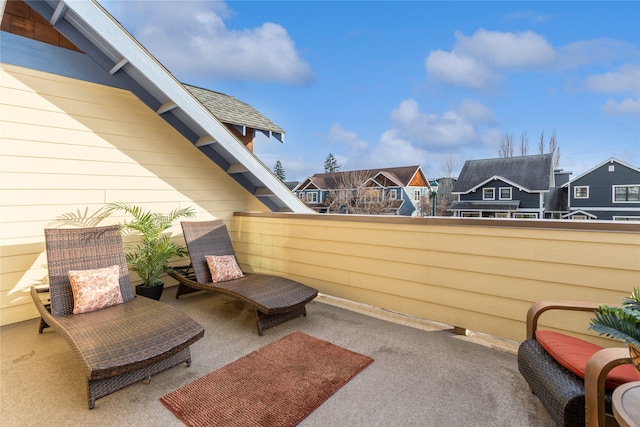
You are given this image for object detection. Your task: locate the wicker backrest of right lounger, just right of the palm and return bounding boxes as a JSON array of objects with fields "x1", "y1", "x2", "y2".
[{"x1": 180, "y1": 219, "x2": 237, "y2": 284}]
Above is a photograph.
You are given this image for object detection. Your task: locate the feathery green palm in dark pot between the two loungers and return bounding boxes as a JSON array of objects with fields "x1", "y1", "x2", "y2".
[{"x1": 107, "y1": 202, "x2": 195, "y2": 299}]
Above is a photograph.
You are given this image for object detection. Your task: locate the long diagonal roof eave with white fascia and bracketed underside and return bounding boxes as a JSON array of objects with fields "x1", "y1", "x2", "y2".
[{"x1": 36, "y1": 0, "x2": 310, "y2": 213}]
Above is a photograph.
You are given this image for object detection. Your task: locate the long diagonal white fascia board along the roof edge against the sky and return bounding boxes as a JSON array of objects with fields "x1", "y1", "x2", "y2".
[{"x1": 65, "y1": 0, "x2": 310, "y2": 213}]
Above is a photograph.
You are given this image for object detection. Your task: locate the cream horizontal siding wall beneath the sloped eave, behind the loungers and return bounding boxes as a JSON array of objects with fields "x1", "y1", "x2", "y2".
[{"x1": 0, "y1": 64, "x2": 267, "y2": 325}]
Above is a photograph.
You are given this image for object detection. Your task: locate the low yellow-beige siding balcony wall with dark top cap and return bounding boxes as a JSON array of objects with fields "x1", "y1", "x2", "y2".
[{"x1": 230, "y1": 213, "x2": 640, "y2": 345}]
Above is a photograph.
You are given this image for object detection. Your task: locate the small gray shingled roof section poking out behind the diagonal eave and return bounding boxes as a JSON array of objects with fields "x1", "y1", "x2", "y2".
[{"x1": 183, "y1": 83, "x2": 284, "y2": 134}]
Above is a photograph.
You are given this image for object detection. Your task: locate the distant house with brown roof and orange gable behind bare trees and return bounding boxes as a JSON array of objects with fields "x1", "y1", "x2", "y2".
[{"x1": 294, "y1": 166, "x2": 430, "y2": 216}]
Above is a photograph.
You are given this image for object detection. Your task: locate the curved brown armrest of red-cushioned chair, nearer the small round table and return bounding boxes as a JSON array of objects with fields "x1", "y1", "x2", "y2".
[{"x1": 584, "y1": 347, "x2": 632, "y2": 427}]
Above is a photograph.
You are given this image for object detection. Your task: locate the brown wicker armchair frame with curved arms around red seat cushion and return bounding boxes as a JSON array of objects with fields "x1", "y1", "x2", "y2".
[{"x1": 518, "y1": 301, "x2": 631, "y2": 427}]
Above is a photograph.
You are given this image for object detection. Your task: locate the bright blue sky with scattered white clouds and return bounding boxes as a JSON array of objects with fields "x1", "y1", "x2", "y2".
[{"x1": 100, "y1": 0, "x2": 640, "y2": 181}]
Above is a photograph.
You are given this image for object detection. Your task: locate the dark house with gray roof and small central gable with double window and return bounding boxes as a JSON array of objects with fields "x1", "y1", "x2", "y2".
[{"x1": 450, "y1": 154, "x2": 559, "y2": 218}]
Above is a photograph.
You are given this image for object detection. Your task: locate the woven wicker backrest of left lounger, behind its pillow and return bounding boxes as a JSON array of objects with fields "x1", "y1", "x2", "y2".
[{"x1": 44, "y1": 225, "x2": 135, "y2": 316}]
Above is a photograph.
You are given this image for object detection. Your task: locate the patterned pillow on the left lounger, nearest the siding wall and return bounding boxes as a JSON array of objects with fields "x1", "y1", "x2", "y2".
[{"x1": 68, "y1": 265, "x2": 122, "y2": 314}]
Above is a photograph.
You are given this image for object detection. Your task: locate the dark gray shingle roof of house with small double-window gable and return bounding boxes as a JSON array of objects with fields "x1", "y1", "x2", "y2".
[{"x1": 453, "y1": 154, "x2": 553, "y2": 193}]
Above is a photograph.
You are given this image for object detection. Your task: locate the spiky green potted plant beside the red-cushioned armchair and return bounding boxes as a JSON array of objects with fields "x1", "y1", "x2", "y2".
[{"x1": 589, "y1": 288, "x2": 640, "y2": 371}]
